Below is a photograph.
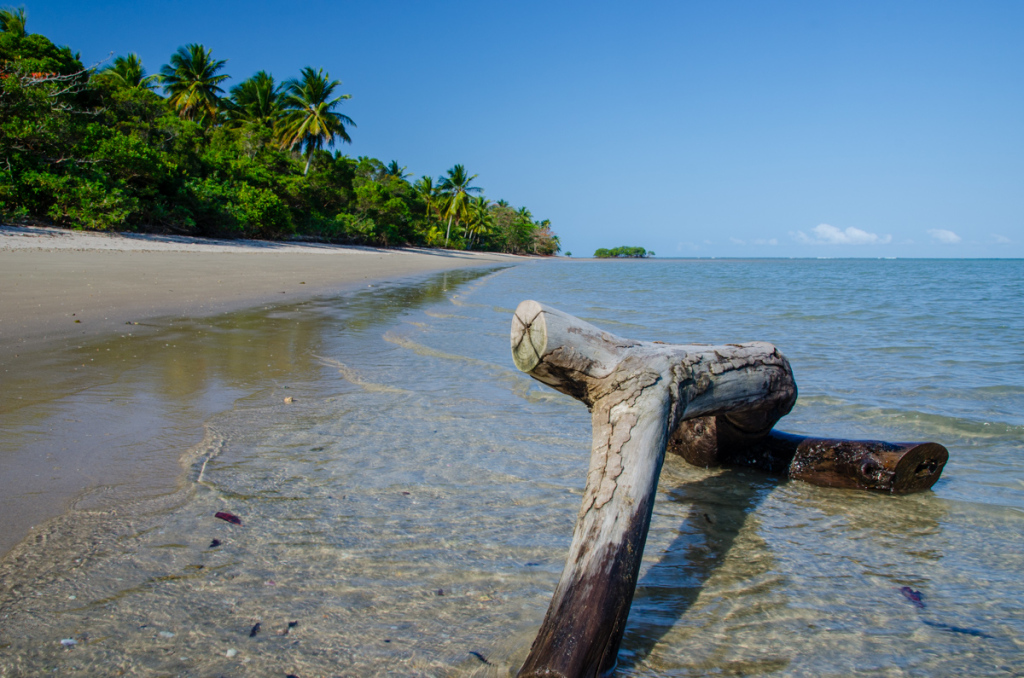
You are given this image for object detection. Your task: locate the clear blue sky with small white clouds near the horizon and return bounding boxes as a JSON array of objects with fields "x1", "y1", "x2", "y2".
[{"x1": 26, "y1": 0, "x2": 1024, "y2": 257}]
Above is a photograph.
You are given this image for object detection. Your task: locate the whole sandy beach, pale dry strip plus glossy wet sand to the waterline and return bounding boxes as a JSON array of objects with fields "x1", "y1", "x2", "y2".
[{"x1": 0, "y1": 226, "x2": 526, "y2": 556}]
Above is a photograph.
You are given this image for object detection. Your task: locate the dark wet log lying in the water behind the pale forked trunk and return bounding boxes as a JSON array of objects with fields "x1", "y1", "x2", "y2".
[{"x1": 668, "y1": 417, "x2": 949, "y2": 495}]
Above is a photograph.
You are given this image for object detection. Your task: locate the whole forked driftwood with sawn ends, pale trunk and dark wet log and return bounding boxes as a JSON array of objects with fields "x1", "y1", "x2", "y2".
[{"x1": 512, "y1": 301, "x2": 944, "y2": 678}]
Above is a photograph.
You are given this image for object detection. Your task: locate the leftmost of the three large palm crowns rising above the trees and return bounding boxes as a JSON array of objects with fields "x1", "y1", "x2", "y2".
[{"x1": 160, "y1": 43, "x2": 230, "y2": 122}]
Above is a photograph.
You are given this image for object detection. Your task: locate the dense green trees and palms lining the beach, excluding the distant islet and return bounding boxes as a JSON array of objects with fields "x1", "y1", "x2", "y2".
[{"x1": 0, "y1": 8, "x2": 560, "y2": 254}]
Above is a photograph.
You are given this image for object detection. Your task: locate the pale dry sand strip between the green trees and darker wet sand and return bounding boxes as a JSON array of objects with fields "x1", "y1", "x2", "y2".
[{"x1": 0, "y1": 226, "x2": 525, "y2": 351}]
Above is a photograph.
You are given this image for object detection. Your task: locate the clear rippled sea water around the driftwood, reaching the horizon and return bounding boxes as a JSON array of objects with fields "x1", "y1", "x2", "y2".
[{"x1": 0, "y1": 260, "x2": 1024, "y2": 678}]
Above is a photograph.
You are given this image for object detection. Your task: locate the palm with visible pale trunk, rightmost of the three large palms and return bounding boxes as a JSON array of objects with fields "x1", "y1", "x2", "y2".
[{"x1": 282, "y1": 67, "x2": 355, "y2": 174}]
